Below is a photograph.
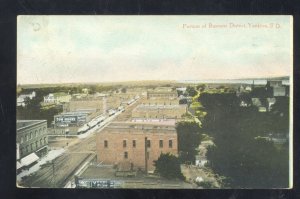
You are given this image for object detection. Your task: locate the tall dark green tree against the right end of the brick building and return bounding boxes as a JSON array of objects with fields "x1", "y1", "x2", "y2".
[{"x1": 176, "y1": 121, "x2": 201, "y2": 162}]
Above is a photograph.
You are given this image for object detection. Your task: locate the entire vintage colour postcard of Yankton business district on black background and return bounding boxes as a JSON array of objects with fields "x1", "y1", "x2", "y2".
[{"x1": 16, "y1": 15, "x2": 293, "y2": 189}]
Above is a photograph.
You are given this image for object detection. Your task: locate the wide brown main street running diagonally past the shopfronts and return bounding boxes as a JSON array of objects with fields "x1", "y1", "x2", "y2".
[{"x1": 19, "y1": 98, "x2": 140, "y2": 188}]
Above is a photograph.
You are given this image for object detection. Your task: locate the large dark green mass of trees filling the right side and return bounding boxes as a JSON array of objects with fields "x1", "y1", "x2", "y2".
[{"x1": 199, "y1": 93, "x2": 288, "y2": 188}]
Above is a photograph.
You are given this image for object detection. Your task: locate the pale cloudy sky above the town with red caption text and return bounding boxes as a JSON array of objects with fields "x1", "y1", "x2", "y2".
[{"x1": 17, "y1": 16, "x2": 292, "y2": 84}]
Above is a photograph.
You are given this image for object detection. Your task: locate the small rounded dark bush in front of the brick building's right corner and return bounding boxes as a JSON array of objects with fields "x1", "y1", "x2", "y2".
[{"x1": 154, "y1": 153, "x2": 184, "y2": 180}]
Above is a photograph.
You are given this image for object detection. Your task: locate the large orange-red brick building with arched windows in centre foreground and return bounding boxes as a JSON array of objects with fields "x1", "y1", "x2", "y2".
[{"x1": 96, "y1": 122, "x2": 178, "y2": 171}]
